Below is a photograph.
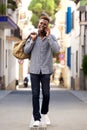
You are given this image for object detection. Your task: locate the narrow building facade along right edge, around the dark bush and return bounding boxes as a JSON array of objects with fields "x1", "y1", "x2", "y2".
[{"x1": 78, "y1": 0, "x2": 87, "y2": 90}]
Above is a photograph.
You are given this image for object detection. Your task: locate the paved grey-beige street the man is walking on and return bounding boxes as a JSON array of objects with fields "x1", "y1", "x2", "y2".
[{"x1": 0, "y1": 89, "x2": 87, "y2": 130}]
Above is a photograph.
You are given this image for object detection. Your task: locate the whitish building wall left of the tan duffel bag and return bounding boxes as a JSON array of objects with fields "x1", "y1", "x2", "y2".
[{"x1": 4, "y1": 29, "x2": 16, "y2": 87}]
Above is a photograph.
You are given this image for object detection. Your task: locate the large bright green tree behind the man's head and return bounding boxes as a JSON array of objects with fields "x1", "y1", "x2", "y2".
[{"x1": 28, "y1": 0, "x2": 60, "y2": 27}]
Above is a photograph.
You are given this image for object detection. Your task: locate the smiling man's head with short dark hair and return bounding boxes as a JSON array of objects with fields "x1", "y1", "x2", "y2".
[{"x1": 38, "y1": 16, "x2": 50, "y2": 35}]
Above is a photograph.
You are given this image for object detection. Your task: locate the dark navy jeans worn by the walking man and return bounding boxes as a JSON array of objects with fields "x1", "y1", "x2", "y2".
[{"x1": 30, "y1": 73, "x2": 50, "y2": 120}]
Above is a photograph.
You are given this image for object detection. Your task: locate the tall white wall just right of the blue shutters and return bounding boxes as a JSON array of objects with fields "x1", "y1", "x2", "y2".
[{"x1": 71, "y1": 4, "x2": 80, "y2": 89}]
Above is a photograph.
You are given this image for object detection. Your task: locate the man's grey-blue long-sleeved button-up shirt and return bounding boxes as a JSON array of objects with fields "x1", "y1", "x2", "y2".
[{"x1": 24, "y1": 35, "x2": 59, "y2": 74}]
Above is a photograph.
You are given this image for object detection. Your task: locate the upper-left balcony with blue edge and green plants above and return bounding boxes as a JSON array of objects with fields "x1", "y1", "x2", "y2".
[{"x1": 0, "y1": 0, "x2": 18, "y2": 29}]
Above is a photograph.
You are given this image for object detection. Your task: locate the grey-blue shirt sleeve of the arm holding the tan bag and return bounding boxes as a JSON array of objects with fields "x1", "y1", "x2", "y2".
[{"x1": 24, "y1": 38, "x2": 35, "y2": 54}]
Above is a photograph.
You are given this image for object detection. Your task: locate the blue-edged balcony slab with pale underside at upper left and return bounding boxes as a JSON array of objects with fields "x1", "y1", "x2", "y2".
[{"x1": 0, "y1": 16, "x2": 18, "y2": 29}]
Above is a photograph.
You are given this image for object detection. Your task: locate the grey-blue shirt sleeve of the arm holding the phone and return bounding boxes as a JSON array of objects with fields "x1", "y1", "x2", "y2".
[{"x1": 47, "y1": 35, "x2": 60, "y2": 53}]
